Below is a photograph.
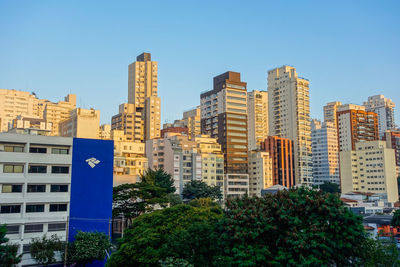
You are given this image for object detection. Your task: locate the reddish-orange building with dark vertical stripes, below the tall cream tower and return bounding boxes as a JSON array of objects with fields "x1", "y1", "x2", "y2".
[{"x1": 261, "y1": 136, "x2": 296, "y2": 188}]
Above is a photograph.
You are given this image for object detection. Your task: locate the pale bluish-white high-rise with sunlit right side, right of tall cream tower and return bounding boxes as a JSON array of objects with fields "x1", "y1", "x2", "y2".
[{"x1": 311, "y1": 120, "x2": 340, "y2": 185}]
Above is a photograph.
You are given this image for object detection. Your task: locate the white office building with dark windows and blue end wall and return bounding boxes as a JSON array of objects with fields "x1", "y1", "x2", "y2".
[{"x1": 0, "y1": 133, "x2": 113, "y2": 266}]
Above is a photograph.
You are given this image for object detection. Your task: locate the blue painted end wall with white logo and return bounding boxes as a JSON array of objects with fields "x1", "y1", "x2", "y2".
[{"x1": 68, "y1": 138, "x2": 114, "y2": 266}]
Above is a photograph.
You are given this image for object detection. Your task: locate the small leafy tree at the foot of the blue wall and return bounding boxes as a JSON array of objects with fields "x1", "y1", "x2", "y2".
[{"x1": 67, "y1": 232, "x2": 111, "y2": 266}]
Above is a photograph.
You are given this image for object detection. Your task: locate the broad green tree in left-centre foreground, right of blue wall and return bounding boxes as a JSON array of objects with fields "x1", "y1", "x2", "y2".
[{"x1": 107, "y1": 204, "x2": 223, "y2": 267}]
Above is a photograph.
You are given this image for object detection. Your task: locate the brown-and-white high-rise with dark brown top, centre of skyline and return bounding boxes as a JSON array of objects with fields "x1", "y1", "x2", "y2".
[{"x1": 200, "y1": 71, "x2": 249, "y2": 197}]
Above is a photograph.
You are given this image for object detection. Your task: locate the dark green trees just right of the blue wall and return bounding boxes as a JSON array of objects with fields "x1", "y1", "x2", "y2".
[{"x1": 113, "y1": 169, "x2": 175, "y2": 218}]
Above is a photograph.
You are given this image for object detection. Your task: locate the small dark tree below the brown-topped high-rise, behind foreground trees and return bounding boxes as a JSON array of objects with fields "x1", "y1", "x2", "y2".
[{"x1": 182, "y1": 180, "x2": 222, "y2": 200}]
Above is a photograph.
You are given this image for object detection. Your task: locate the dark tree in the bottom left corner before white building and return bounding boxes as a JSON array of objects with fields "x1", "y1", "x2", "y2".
[{"x1": 0, "y1": 225, "x2": 22, "y2": 267}]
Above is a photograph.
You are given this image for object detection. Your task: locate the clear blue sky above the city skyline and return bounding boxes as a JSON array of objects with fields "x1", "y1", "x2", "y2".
[{"x1": 0, "y1": 0, "x2": 400, "y2": 124}]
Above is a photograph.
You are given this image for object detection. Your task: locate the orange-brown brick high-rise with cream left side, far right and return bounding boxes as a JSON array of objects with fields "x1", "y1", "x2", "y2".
[{"x1": 337, "y1": 104, "x2": 379, "y2": 151}]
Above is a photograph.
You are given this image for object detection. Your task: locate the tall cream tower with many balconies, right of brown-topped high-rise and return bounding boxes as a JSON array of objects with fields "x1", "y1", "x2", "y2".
[{"x1": 268, "y1": 66, "x2": 313, "y2": 185}]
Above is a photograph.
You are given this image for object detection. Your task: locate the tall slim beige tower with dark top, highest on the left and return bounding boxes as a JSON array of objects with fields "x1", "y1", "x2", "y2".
[{"x1": 128, "y1": 53, "x2": 161, "y2": 140}]
